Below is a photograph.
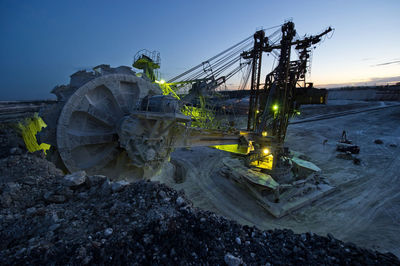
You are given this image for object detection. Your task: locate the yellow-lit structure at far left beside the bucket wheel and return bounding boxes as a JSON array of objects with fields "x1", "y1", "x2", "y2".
[{"x1": 18, "y1": 114, "x2": 50, "y2": 154}]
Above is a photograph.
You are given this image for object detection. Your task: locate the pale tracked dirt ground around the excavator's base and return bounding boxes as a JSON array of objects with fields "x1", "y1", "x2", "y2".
[{"x1": 162, "y1": 101, "x2": 400, "y2": 257}]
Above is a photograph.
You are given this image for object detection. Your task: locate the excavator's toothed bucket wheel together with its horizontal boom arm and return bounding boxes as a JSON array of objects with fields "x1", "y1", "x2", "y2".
[{"x1": 38, "y1": 62, "x2": 239, "y2": 180}]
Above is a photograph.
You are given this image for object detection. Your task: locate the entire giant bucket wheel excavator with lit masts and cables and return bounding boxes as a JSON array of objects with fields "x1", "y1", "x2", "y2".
[{"x1": 38, "y1": 22, "x2": 332, "y2": 217}]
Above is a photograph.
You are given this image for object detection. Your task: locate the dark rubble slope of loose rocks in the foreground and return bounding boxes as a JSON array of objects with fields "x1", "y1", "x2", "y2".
[{"x1": 0, "y1": 103, "x2": 400, "y2": 265}]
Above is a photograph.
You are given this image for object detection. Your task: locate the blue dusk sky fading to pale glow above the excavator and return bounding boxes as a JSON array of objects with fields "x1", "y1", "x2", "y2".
[{"x1": 0, "y1": 0, "x2": 400, "y2": 100}]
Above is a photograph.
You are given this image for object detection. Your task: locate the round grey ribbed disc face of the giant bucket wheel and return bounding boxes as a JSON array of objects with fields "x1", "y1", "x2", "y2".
[{"x1": 51, "y1": 74, "x2": 171, "y2": 180}]
